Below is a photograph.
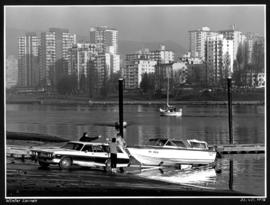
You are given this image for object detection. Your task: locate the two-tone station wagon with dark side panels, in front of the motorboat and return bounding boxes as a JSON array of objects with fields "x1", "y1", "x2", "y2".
[{"x1": 31, "y1": 141, "x2": 129, "y2": 169}]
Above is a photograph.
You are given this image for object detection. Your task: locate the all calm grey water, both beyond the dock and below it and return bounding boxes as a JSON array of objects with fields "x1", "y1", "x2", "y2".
[{"x1": 6, "y1": 104, "x2": 265, "y2": 196}]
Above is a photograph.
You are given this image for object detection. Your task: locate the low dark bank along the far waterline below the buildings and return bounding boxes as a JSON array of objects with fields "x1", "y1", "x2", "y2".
[{"x1": 6, "y1": 94, "x2": 265, "y2": 105}]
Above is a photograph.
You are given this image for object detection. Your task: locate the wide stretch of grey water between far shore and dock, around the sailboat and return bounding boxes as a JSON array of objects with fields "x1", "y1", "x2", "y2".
[{"x1": 6, "y1": 104, "x2": 265, "y2": 144}]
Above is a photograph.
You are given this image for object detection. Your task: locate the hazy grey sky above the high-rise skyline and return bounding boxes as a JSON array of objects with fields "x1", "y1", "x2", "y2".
[{"x1": 6, "y1": 5, "x2": 265, "y2": 47}]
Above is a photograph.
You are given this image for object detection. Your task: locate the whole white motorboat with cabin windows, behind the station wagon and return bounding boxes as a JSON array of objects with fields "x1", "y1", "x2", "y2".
[{"x1": 127, "y1": 138, "x2": 216, "y2": 166}]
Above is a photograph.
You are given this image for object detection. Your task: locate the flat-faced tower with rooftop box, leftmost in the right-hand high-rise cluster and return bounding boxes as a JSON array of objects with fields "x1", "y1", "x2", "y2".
[{"x1": 189, "y1": 27, "x2": 216, "y2": 61}]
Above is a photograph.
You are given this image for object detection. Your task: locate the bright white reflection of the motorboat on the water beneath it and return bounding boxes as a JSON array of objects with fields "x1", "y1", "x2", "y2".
[{"x1": 137, "y1": 168, "x2": 216, "y2": 188}]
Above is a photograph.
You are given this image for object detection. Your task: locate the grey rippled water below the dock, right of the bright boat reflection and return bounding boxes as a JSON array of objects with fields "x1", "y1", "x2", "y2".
[{"x1": 215, "y1": 154, "x2": 266, "y2": 196}]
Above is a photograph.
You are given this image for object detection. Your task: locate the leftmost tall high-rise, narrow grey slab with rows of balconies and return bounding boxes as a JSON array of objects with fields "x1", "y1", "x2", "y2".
[{"x1": 18, "y1": 33, "x2": 40, "y2": 87}]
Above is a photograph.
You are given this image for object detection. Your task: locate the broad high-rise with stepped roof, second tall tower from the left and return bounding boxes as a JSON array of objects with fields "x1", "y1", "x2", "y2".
[{"x1": 40, "y1": 28, "x2": 76, "y2": 86}]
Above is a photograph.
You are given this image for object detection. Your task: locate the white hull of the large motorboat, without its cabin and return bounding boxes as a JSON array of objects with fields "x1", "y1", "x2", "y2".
[{"x1": 127, "y1": 147, "x2": 216, "y2": 166}]
